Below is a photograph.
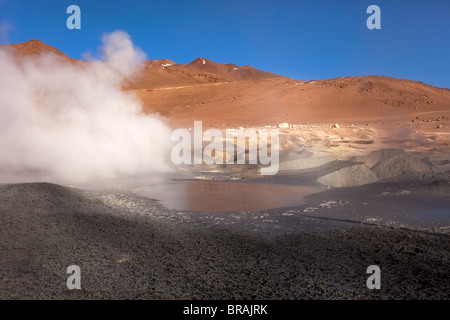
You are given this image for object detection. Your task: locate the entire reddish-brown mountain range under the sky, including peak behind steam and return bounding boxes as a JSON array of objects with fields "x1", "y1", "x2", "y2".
[{"x1": 3, "y1": 40, "x2": 450, "y2": 128}]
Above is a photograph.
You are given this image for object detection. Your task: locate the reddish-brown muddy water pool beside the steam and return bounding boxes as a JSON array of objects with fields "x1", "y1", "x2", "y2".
[{"x1": 133, "y1": 180, "x2": 322, "y2": 212}]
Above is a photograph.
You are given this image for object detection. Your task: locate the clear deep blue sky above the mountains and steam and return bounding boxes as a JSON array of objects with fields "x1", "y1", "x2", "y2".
[{"x1": 0, "y1": 0, "x2": 450, "y2": 88}]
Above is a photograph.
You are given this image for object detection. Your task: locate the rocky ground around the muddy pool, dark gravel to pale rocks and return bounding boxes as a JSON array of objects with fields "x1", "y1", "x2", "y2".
[{"x1": 0, "y1": 119, "x2": 450, "y2": 299}]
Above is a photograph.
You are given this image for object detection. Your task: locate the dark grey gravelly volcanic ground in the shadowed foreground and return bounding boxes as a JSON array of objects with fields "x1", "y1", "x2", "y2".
[{"x1": 0, "y1": 181, "x2": 450, "y2": 299}]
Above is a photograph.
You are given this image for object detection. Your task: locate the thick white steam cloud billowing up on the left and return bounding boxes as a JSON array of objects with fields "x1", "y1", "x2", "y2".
[{"x1": 0, "y1": 32, "x2": 170, "y2": 182}]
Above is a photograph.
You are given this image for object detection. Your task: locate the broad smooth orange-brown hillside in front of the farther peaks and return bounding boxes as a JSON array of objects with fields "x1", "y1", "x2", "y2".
[{"x1": 136, "y1": 76, "x2": 450, "y2": 127}]
